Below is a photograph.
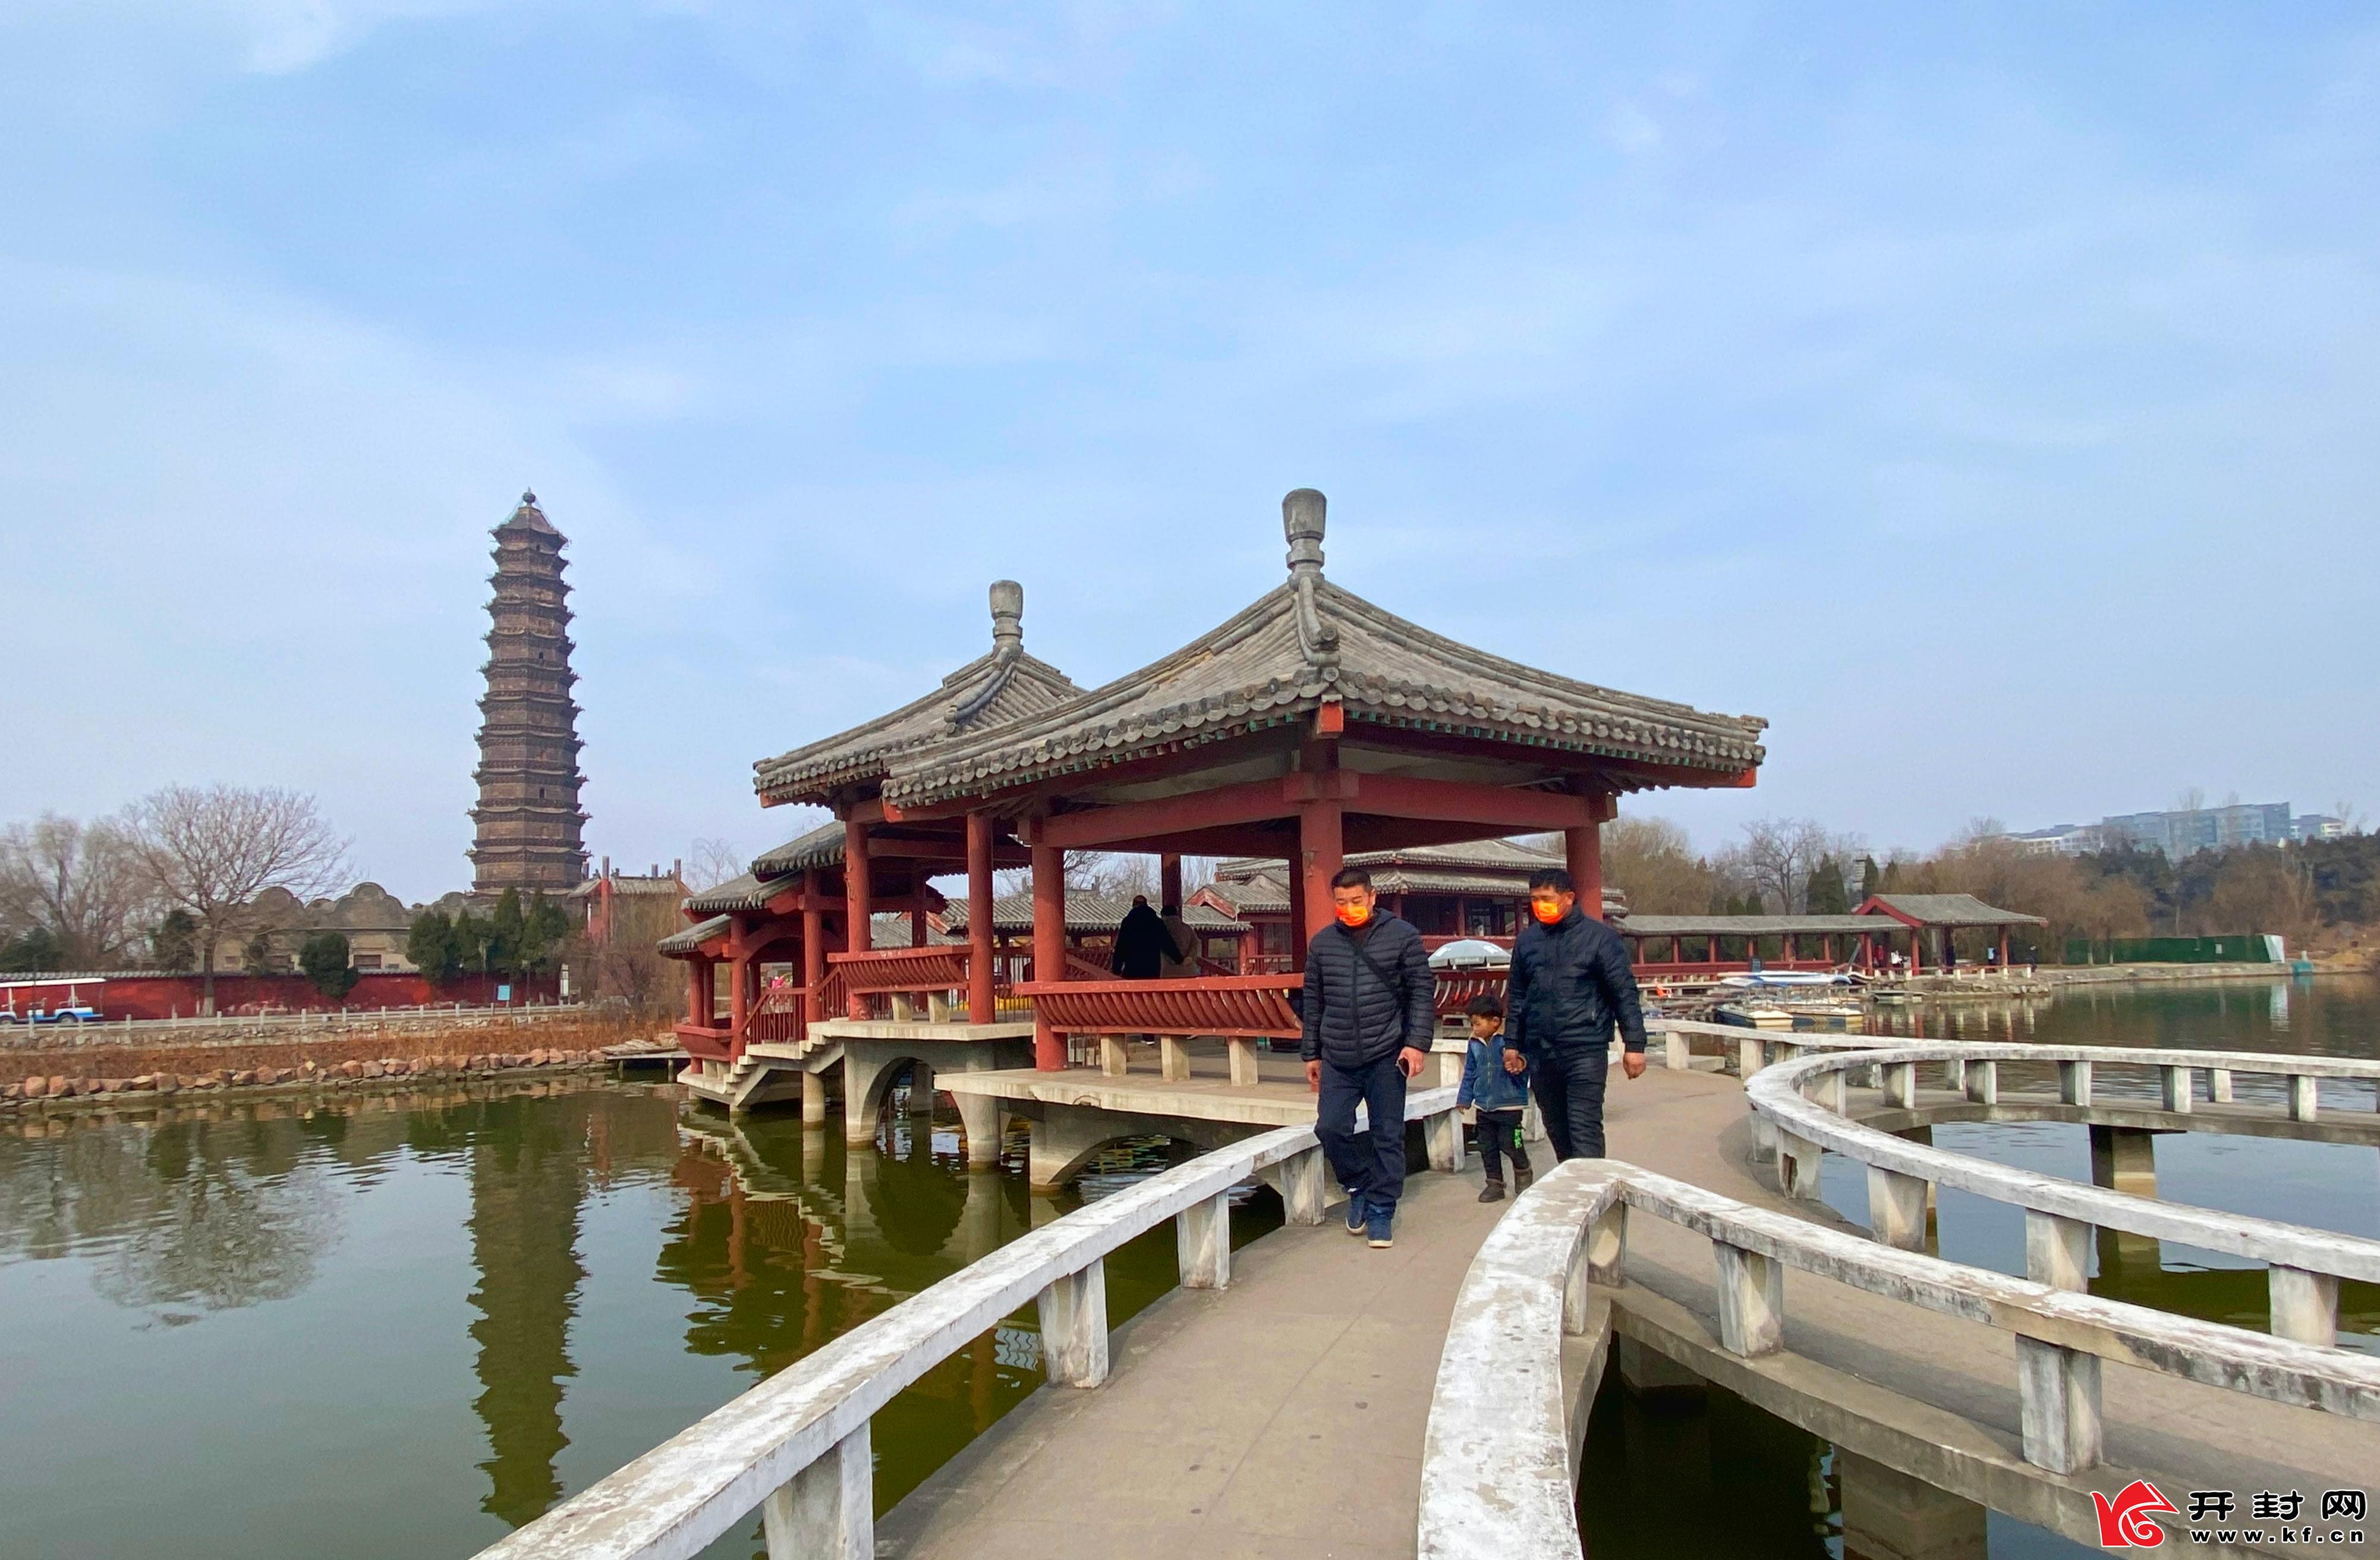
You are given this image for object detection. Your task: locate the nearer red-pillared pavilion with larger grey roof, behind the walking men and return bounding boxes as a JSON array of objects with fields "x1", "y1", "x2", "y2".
[{"x1": 857, "y1": 488, "x2": 1766, "y2": 1070}]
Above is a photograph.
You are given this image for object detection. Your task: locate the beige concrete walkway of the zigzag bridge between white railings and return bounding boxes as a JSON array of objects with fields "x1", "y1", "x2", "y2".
[{"x1": 878, "y1": 1072, "x2": 2380, "y2": 1560}]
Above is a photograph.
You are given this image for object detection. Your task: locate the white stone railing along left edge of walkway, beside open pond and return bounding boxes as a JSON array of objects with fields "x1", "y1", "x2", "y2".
[{"x1": 481, "y1": 1100, "x2": 1333, "y2": 1560}]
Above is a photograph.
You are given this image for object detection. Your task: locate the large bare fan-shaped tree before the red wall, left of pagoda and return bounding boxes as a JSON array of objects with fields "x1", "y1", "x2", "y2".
[{"x1": 124, "y1": 786, "x2": 348, "y2": 1012}]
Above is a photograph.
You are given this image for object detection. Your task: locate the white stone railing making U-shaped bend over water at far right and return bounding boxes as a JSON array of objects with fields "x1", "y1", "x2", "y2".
[{"x1": 1745, "y1": 1036, "x2": 2380, "y2": 1345}]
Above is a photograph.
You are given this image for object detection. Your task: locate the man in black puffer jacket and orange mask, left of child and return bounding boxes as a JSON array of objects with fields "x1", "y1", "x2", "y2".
[{"x1": 1299, "y1": 867, "x2": 1437, "y2": 1250}]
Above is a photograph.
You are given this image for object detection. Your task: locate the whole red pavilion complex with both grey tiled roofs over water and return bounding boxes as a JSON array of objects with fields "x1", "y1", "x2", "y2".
[{"x1": 664, "y1": 490, "x2": 1764, "y2": 1191}]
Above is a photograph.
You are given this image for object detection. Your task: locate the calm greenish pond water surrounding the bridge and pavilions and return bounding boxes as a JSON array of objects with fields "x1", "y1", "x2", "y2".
[{"x1": 0, "y1": 982, "x2": 2380, "y2": 1560}]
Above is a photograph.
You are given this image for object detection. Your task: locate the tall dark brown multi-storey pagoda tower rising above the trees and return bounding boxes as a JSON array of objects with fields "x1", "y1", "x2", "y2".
[{"x1": 471, "y1": 493, "x2": 588, "y2": 895}]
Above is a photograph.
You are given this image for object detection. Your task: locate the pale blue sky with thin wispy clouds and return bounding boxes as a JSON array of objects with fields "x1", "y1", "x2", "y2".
[{"x1": 0, "y1": 0, "x2": 2380, "y2": 898}]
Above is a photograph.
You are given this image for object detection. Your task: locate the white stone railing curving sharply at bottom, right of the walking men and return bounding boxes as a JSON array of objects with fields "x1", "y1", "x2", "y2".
[{"x1": 1418, "y1": 1160, "x2": 2380, "y2": 1560}]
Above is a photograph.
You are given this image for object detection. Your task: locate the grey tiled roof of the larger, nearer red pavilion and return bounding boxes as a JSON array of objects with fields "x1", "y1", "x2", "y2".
[{"x1": 883, "y1": 490, "x2": 1766, "y2": 807}]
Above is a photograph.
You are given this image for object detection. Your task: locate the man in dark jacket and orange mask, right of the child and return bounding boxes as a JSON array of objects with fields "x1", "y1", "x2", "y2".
[{"x1": 1504, "y1": 867, "x2": 1645, "y2": 1160}]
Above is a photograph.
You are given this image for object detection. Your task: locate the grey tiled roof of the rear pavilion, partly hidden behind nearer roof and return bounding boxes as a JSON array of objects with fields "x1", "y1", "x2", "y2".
[{"x1": 752, "y1": 578, "x2": 1081, "y2": 803}]
